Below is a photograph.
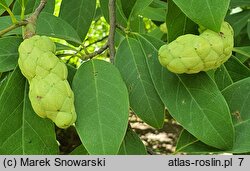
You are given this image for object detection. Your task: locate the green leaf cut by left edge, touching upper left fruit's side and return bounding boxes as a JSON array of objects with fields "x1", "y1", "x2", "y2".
[{"x1": 0, "y1": 37, "x2": 23, "y2": 72}]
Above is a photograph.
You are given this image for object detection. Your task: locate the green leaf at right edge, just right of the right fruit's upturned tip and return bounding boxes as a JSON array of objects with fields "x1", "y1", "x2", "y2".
[{"x1": 226, "y1": 10, "x2": 250, "y2": 36}]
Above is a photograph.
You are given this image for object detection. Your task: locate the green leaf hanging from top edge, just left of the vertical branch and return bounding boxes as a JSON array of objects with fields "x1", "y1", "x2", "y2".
[{"x1": 59, "y1": 0, "x2": 96, "y2": 40}]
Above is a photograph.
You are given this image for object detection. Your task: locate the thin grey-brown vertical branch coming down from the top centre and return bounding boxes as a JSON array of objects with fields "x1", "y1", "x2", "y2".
[{"x1": 108, "y1": 0, "x2": 116, "y2": 63}]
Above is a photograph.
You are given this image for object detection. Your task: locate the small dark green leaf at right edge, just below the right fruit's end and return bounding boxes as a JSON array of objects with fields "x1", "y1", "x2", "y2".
[{"x1": 224, "y1": 56, "x2": 250, "y2": 82}]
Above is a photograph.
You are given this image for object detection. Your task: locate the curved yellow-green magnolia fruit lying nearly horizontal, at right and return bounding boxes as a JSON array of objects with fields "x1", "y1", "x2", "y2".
[{"x1": 158, "y1": 22, "x2": 234, "y2": 74}]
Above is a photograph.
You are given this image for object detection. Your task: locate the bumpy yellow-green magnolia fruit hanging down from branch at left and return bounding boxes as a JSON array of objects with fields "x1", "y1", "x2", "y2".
[{"x1": 18, "y1": 35, "x2": 76, "y2": 128}]
